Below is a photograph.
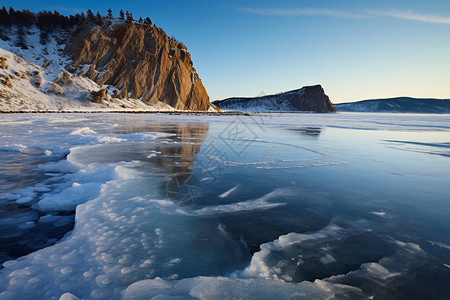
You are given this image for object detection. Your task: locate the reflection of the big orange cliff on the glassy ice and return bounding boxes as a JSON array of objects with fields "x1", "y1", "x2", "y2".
[{"x1": 97, "y1": 118, "x2": 209, "y2": 205}]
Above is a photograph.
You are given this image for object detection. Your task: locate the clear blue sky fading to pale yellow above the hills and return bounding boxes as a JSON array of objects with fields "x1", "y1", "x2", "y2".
[{"x1": 0, "y1": 0, "x2": 450, "y2": 103}]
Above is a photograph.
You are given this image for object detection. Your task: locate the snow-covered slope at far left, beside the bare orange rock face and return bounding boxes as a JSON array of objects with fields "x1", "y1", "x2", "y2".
[{"x1": 0, "y1": 26, "x2": 205, "y2": 112}]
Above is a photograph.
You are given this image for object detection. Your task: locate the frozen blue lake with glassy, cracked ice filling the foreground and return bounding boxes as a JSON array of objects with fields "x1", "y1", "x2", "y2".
[{"x1": 0, "y1": 113, "x2": 450, "y2": 299}]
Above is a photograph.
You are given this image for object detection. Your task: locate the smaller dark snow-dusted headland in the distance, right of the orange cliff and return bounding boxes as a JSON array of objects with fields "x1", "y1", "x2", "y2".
[{"x1": 213, "y1": 85, "x2": 335, "y2": 113}]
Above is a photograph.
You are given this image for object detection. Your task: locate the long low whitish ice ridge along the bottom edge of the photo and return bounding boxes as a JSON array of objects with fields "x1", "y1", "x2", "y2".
[{"x1": 123, "y1": 277, "x2": 362, "y2": 300}]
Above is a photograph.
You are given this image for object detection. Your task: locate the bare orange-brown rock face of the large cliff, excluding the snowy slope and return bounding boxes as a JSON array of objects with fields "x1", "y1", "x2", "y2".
[{"x1": 65, "y1": 20, "x2": 210, "y2": 111}]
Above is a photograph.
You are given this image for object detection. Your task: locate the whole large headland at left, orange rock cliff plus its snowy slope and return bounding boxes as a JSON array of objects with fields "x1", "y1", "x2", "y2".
[{"x1": 0, "y1": 14, "x2": 217, "y2": 112}]
